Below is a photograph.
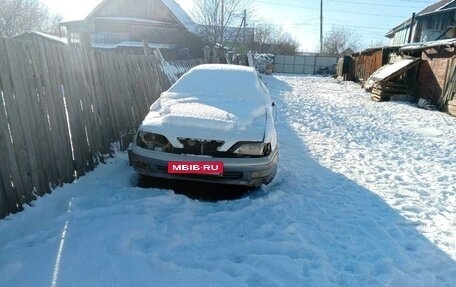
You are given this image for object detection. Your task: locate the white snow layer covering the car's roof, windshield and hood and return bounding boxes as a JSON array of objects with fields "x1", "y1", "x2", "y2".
[{"x1": 143, "y1": 64, "x2": 270, "y2": 143}]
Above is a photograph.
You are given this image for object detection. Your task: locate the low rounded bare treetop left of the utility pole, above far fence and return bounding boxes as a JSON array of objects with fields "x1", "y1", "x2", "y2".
[{"x1": 254, "y1": 22, "x2": 299, "y2": 55}]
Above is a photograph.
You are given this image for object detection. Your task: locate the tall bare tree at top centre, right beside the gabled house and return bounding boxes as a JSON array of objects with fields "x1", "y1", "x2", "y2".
[{"x1": 192, "y1": 0, "x2": 253, "y2": 45}]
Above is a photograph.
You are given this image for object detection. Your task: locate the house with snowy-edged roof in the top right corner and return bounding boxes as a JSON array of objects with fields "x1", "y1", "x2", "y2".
[{"x1": 385, "y1": 0, "x2": 456, "y2": 45}]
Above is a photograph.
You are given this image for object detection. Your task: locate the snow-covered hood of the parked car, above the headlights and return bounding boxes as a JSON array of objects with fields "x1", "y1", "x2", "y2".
[{"x1": 141, "y1": 93, "x2": 266, "y2": 151}]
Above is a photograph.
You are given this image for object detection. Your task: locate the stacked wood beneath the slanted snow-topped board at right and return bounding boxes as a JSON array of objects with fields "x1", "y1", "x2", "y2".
[{"x1": 372, "y1": 81, "x2": 413, "y2": 102}]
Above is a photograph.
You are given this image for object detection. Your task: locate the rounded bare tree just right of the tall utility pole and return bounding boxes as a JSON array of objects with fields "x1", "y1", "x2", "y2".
[{"x1": 323, "y1": 26, "x2": 360, "y2": 57}]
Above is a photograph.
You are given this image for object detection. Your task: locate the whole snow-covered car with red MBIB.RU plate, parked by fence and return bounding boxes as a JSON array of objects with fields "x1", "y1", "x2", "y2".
[{"x1": 128, "y1": 64, "x2": 278, "y2": 187}]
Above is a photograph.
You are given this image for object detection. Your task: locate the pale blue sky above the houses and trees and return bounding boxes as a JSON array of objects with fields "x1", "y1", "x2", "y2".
[{"x1": 43, "y1": 0, "x2": 437, "y2": 51}]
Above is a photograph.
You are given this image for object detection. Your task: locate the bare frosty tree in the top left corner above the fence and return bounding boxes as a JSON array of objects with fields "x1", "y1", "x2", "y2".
[{"x1": 0, "y1": 0, "x2": 62, "y2": 37}]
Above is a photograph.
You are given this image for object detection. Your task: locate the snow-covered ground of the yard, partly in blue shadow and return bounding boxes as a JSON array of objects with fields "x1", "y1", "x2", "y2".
[{"x1": 0, "y1": 76, "x2": 456, "y2": 287}]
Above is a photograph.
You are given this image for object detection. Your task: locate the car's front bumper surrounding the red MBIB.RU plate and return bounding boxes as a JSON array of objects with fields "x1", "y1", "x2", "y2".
[{"x1": 128, "y1": 145, "x2": 278, "y2": 187}]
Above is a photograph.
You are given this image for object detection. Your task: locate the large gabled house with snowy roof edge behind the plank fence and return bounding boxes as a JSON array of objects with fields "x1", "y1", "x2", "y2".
[{"x1": 60, "y1": 0, "x2": 204, "y2": 59}]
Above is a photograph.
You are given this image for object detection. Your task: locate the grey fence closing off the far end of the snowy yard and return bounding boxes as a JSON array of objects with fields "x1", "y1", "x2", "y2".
[{"x1": 274, "y1": 55, "x2": 338, "y2": 75}]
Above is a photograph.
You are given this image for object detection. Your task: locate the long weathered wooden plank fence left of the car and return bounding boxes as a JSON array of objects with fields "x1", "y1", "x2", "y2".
[{"x1": 0, "y1": 39, "x2": 201, "y2": 218}]
